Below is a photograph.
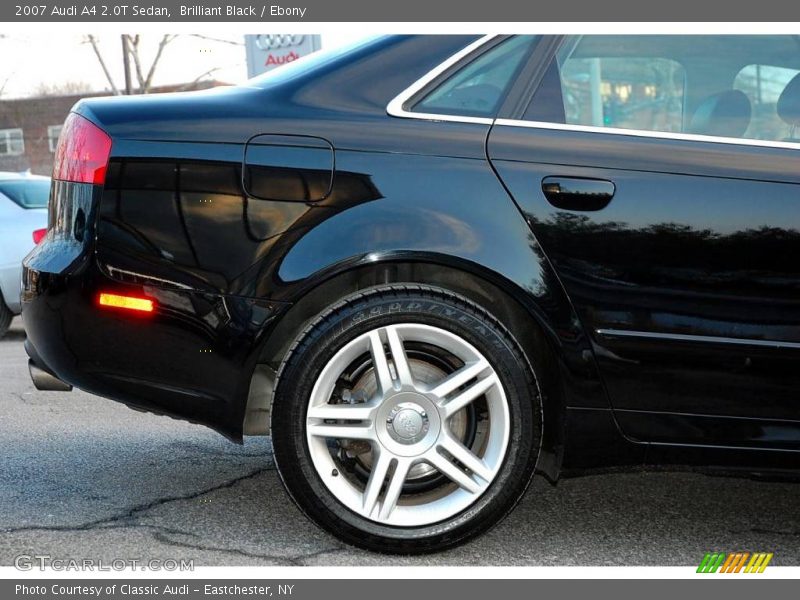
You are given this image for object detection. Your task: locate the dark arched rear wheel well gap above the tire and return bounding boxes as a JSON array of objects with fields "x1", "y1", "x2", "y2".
[{"x1": 245, "y1": 262, "x2": 565, "y2": 480}]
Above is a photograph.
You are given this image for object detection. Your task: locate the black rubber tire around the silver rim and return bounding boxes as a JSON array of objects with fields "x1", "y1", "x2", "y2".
[{"x1": 272, "y1": 285, "x2": 541, "y2": 554}]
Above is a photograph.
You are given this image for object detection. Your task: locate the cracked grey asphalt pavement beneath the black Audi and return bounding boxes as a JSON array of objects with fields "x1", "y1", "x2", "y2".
[{"x1": 0, "y1": 319, "x2": 800, "y2": 566}]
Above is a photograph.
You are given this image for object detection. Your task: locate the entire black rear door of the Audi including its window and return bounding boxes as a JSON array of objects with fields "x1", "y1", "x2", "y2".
[{"x1": 487, "y1": 36, "x2": 800, "y2": 450}]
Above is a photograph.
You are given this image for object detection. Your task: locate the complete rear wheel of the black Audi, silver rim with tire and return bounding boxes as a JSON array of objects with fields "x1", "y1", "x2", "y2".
[{"x1": 272, "y1": 287, "x2": 540, "y2": 552}]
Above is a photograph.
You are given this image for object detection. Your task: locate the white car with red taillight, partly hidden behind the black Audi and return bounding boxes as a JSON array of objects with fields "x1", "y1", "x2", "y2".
[{"x1": 0, "y1": 171, "x2": 50, "y2": 338}]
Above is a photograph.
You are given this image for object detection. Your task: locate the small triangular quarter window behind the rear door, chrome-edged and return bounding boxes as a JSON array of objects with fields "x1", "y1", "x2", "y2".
[{"x1": 411, "y1": 35, "x2": 535, "y2": 117}]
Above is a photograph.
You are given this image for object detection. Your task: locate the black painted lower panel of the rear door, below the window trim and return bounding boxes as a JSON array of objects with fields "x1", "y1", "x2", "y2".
[{"x1": 489, "y1": 126, "x2": 800, "y2": 449}]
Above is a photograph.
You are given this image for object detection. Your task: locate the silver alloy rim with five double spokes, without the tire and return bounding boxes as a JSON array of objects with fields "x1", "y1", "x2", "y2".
[{"x1": 306, "y1": 323, "x2": 510, "y2": 527}]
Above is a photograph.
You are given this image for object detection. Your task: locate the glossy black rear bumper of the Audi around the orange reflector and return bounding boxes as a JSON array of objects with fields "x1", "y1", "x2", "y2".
[{"x1": 22, "y1": 184, "x2": 286, "y2": 440}]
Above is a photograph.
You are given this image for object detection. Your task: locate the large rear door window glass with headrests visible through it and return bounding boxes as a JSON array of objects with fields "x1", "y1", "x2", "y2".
[{"x1": 524, "y1": 35, "x2": 800, "y2": 142}]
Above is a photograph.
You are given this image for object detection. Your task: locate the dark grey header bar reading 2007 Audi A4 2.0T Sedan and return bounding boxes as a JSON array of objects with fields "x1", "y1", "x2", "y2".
[{"x1": 0, "y1": 0, "x2": 800, "y2": 21}]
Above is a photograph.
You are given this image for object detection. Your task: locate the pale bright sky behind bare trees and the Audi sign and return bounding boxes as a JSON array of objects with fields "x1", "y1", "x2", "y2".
[{"x1": 0, "y1": 30, "x2": 357, "y2": 99}]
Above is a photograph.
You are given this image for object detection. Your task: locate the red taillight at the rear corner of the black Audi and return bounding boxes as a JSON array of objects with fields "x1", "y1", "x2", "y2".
[{"x1": 53, "y1": 113, "x2": 111, "y2": 185}]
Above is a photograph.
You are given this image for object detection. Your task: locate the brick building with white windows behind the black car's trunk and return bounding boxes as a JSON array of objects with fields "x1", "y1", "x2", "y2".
[{"x1": 0, "y1": 81, "x2": 227, "y2": 175}]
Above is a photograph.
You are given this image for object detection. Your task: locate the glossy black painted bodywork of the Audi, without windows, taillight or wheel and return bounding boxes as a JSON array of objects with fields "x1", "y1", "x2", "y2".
[{"x1": 24, "y1": 36, "x2": 800, "y2": 478}]
